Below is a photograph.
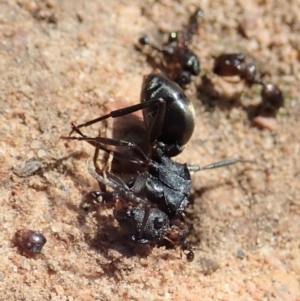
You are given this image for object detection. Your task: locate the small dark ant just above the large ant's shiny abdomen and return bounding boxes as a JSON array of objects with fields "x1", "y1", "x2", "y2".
[{"x1": 139, "y1": 8, "x2": 203, "y2": 87}]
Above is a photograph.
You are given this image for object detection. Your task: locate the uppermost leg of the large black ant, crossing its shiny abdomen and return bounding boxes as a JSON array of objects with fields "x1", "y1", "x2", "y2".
[{"x1": 69, "y1": 99, "x2": 168, "y2": 135}]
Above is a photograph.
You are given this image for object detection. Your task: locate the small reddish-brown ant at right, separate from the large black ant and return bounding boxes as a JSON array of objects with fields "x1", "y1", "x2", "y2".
[{"x1": 213, "y1": 53, "x2": 284, "y2": 114}]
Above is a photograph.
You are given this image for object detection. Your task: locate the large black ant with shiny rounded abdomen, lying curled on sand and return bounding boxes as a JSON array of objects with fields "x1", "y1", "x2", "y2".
[{"x1": 62, "y1": 74, "x2": 243, "y2": 260}]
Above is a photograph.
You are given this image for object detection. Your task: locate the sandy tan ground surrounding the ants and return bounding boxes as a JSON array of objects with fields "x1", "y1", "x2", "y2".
[{"x1": 0, "y1": 0, "x2": 300, "y2": 301}]
